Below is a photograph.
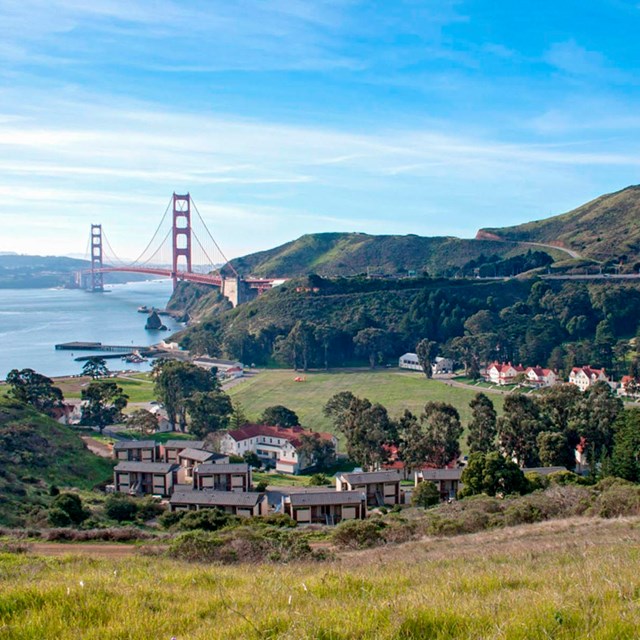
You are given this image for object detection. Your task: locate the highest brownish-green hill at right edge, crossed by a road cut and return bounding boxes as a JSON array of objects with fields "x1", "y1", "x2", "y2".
[{"x1": 476, "y1": 185, "x2": 640, "y2": 270}]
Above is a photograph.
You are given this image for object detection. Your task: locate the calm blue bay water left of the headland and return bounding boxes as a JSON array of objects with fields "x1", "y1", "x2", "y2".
[{"x1": 0, "y1": 280, "x2": 180, "y2": 379}]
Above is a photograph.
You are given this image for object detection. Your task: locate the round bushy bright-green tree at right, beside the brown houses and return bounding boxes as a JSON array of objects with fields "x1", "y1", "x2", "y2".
[{"x1": 460, "y1": 451, "x2": 529, "y2": 498}]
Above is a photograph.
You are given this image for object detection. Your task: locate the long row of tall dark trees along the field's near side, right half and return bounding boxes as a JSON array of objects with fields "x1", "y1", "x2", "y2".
[{"x1": 324, "y1": 382, "x2": 640, "y2": 479}]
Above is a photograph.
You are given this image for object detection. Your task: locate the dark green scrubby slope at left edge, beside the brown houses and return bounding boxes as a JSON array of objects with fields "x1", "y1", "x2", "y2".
[{"x1": 0, "y1": 396, "x2": 113, "y2": 526}]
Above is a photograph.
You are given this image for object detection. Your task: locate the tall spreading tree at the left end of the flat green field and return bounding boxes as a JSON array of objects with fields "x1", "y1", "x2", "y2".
[{"x1": 151, "y1": 360, "x2": 220, "y2": 431}]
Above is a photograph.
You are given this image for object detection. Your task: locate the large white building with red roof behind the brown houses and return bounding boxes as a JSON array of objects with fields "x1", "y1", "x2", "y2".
[{"x1": 220, "y1": 424, "x2": 338, "y2": 473}]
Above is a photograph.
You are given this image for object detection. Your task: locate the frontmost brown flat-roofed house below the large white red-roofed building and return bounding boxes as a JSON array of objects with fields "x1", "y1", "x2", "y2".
[{"x1": 281, "y1": 489, "x2": 367, "y2": 525}]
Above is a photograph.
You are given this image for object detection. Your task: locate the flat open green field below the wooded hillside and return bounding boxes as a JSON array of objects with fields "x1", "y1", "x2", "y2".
[{"x1": 228, "y1": 369, "x2": 504, "y2": 438}]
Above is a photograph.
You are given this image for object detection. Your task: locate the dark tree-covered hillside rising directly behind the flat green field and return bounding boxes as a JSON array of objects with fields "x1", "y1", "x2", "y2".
[{"x1": 182, "y1": 276, "x2": 640, "y2": 376}]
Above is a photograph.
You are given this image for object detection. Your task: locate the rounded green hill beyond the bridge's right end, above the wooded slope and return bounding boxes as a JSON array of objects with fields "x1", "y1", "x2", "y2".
[{"x1": 224, "y1": 233, "x2": 566, "y2": 278}]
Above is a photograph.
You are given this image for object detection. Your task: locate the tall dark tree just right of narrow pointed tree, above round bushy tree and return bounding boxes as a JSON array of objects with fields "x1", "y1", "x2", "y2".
[{"x1": 498, "y1": 393, "x2": 544, "y2": 467}]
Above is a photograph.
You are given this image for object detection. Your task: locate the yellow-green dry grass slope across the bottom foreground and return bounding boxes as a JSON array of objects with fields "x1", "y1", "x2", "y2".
[{"x1": 0, "y1": 518, "x2": 640, "y2": 640}]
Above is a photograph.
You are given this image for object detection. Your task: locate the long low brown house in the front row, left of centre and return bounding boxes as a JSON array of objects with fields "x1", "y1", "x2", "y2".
[{"x1": 169, "y1": 488, "x2": 269, "y2": 518}]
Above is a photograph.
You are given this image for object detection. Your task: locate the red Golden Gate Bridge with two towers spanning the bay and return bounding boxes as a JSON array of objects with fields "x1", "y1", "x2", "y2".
[{"x1": 77, "y1": 193, "x2": 276, "y2": 306}]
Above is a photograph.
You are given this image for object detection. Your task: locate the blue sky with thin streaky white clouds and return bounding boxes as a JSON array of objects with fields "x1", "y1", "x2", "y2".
[{"x1": 0, "y1": 0, "x2": 640, "y2": 256}]
